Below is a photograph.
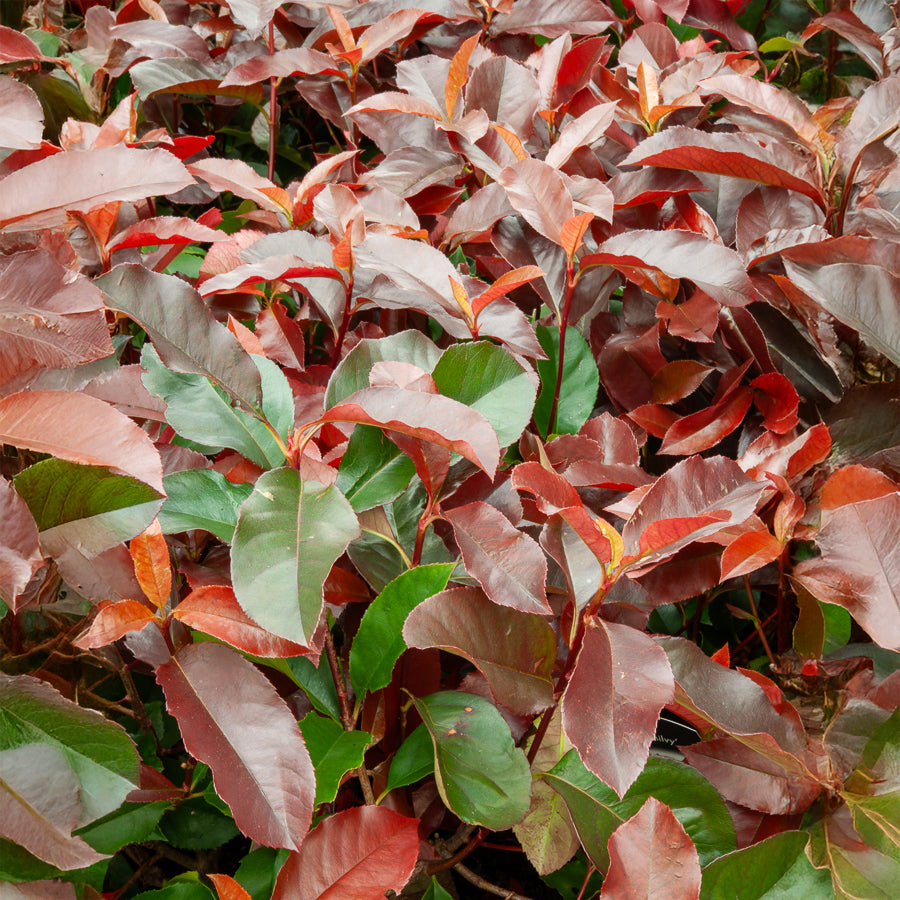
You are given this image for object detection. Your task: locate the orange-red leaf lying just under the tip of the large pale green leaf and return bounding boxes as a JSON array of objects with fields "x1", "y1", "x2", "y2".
[{"x1": 172, "y1": 586, "x2": 309, "y2": 659}]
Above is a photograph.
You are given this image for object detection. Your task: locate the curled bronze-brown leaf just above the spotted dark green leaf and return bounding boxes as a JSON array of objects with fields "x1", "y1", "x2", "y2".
[{"x1": 403, "y1": 584, "x2": 556, "y2": 715}]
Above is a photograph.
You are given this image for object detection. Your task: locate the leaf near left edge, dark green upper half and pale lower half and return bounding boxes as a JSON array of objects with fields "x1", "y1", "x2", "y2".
[{"x1": 13, "y1": 459, "x2": 162, "y2": 556}]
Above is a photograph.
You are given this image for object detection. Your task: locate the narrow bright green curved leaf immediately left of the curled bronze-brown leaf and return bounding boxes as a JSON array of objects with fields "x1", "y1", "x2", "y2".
[{"x1": 350, "y1": 563, "x2": 454, "y2": 700}]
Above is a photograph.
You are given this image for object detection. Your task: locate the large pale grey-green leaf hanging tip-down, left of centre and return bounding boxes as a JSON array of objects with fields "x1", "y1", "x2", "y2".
[{"x1": 231, "y1": 468, "x2": 360, "y2": 646}]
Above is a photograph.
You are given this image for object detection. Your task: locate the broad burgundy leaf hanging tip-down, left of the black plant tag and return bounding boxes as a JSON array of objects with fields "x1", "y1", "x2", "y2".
[{"x1": 562, "y1": 619, "x2": 675, "y2": 797}]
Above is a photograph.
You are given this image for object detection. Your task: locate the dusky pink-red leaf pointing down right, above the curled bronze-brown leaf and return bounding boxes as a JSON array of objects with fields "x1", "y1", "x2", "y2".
[{"x1": 444, "y1": 503, "x2": 551, "y2": 613}]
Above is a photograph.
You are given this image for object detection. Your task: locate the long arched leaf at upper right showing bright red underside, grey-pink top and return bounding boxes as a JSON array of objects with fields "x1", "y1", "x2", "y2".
[{"x1": 622, "y1": 125, "x2": 825, "y2": 208}]
